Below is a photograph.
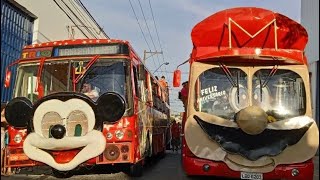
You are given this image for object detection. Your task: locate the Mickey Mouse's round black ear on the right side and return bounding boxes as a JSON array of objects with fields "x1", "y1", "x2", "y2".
[{"x1": 97, "y1": 92, "x2": 126, "y2": 123}]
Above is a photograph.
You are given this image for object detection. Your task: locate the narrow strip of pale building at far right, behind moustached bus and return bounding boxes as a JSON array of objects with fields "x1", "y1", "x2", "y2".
[{"x1": 301, "y1": 0, "x2": 319, "y2": 126}]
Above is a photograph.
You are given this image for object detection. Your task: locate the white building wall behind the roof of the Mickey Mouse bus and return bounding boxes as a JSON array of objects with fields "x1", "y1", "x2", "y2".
[{"x1": 15, "y1": 0, "x2": 109, "y2": 44}]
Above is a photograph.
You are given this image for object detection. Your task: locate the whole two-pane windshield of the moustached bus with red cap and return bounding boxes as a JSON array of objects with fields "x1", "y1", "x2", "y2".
[{"x1": 195, "y1": 66, "x2": 306, "y2": 121}]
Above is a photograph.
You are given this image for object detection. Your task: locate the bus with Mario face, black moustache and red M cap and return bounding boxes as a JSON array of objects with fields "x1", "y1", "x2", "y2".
[{"x1": 174, "y1": 7, "x2": 319, "y2": 179}]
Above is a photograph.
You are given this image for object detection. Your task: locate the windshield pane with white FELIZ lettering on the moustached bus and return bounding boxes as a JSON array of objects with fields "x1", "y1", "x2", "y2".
[{"x1": 195, "y1": 67, "x2": 249, "y2": 120}]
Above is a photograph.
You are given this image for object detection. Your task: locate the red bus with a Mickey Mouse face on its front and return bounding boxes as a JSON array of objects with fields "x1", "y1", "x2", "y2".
[{"x1": 4, "y1": 39, "x2": 170, "y2": 177}]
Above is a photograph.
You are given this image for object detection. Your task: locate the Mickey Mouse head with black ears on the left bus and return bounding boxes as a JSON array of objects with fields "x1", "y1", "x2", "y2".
[{"x1": 5, "y1": 92, "x2": 125, "y2": 171}]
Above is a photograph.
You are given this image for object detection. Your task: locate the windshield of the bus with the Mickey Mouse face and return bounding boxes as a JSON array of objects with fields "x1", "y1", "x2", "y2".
[{"x1": 15, "y1": 58, "x2": 131, "y2": 112}]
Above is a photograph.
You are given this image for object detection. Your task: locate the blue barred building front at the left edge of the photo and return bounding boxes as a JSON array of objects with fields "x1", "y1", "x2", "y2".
[{"x1": 1, "y1": 0, "x2": 37, "y2": 103}]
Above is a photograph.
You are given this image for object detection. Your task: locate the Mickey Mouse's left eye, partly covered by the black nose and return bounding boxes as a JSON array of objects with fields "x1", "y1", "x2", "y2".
[{"x1": 41, "y1": 111, "x2": 63, "y2": 138}]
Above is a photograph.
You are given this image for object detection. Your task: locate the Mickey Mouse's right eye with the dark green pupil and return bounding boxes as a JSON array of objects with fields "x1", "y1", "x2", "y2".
[{"x1": 67, "y1": 110, "x2": 88, "y2": 137}]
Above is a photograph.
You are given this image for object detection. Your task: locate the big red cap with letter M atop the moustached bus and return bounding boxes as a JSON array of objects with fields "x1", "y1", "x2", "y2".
[{"x1": 191, "y1": 7, "x2": 308, "y2": 64}]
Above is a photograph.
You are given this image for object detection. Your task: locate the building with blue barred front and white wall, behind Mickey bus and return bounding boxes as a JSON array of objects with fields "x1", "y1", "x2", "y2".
[{"x1": 1, "y1": 0, "x2": 109, "y2": 103}]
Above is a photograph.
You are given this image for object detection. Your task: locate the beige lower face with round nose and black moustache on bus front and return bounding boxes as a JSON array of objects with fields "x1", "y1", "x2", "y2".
[{"x1": 184, "y1": 107, "x2": 319, "y2": 173}]
